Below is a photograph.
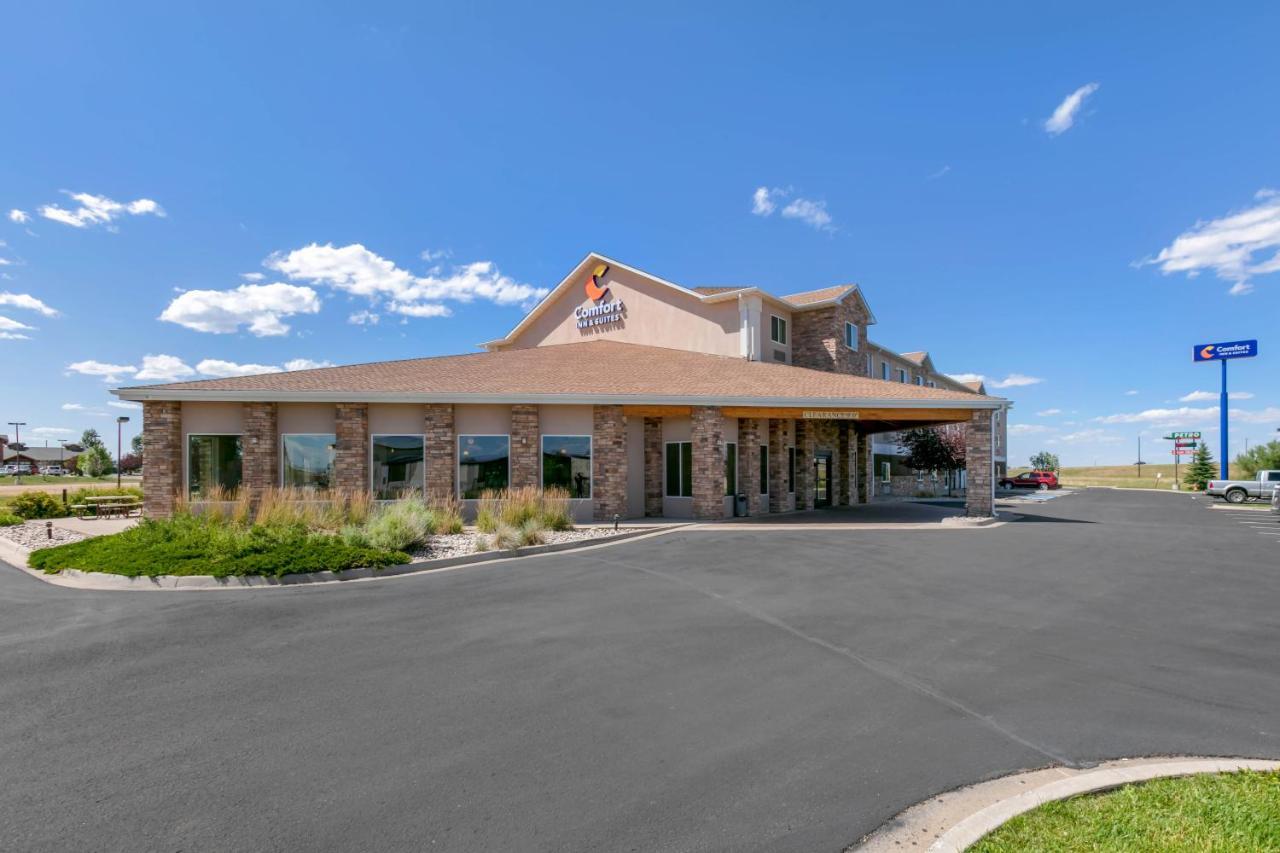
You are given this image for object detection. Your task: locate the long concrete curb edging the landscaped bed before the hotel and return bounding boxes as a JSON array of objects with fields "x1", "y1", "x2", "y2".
[{"x1": 0, "y1": 525, "x2": 684, "y2": 592}]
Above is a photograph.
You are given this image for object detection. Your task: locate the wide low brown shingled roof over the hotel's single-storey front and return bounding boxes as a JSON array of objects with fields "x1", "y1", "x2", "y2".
[{"x1": 116, "y1": 341, "x2": 1003, "y2": 406}]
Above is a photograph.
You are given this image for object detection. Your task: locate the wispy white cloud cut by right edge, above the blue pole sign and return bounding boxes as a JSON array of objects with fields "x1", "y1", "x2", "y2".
[{"x1": 1138, "y1": 190, "x2": 1280, "y2": 296}]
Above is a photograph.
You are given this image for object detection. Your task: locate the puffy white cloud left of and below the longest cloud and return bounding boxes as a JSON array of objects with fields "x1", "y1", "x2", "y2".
[{"x1": 160, "y1": 283, "x2": 320, "y2": 337}]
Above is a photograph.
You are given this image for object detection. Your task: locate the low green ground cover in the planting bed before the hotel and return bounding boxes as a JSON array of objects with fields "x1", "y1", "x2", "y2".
[{"x1": 29, "y1": 515, "x2": 410, "y2": 578}]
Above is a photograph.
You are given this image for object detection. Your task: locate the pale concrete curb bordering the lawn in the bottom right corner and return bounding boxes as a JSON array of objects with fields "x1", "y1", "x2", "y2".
[{"x1": 850, "y1": 756, "x2": 1280, "y2": 853}]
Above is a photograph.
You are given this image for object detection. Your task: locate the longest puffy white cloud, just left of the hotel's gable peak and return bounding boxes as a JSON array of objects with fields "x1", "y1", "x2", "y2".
[{"x1": 266, "y1": 243, "x2": 548, "y2": 316}]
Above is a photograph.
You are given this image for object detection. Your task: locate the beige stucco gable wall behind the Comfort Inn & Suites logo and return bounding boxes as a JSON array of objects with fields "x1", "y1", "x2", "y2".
[{"x1": 508, "y1": 266, "x2": 740, "y2": 356}]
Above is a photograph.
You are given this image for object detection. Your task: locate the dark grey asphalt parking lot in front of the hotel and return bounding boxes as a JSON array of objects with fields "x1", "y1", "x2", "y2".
[{"x1": 0, "y1": 489, "x2": 1280, "y2": 852}]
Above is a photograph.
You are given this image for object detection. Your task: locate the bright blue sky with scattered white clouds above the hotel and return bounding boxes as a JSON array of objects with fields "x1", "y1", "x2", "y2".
[{"x1": 0, "y1": 3, "x2": 1280, "y2": 464}]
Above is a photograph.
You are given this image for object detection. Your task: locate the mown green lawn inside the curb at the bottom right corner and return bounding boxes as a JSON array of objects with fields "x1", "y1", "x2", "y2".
[{"x1": 969, "y1": 771, "x2": 1280, "y2": 853}]
